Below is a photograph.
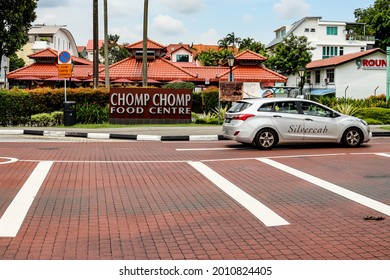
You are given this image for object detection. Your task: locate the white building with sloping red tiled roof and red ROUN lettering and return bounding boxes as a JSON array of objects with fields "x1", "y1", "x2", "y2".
[{"x1": 304, "y1": 49, "x2": 387, "y2": 99}]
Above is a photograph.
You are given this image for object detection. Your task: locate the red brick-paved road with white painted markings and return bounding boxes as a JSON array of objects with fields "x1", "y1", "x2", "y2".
[{"x1": 0, "y1": 136, "x2": 390, "y2": 260}]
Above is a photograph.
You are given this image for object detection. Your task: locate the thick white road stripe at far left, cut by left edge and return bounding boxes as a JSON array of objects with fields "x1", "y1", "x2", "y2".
[{"x1": 0, "y1": 161, "x2": 53, "y2": 237}]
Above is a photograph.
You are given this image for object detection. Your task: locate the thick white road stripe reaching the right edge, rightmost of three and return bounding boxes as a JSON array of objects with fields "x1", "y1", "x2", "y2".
[{"x1": 257, "y1": 158, "x2": 390, "y2": 216}]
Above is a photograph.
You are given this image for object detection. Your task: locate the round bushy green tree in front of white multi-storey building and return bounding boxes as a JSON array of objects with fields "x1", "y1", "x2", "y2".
[{"x1": 265, "y1": 34, "x2": 314, "y2": 76}]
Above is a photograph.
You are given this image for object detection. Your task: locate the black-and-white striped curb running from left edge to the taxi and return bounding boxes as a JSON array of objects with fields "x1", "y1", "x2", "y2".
[{"x1": 0, "y1": 130, "x2": 227, "y2": 141}]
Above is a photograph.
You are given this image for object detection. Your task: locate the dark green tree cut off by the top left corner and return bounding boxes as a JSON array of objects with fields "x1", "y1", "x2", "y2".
[{"x1": 0, "y1": 0, "x2": 38, "y2": 68}]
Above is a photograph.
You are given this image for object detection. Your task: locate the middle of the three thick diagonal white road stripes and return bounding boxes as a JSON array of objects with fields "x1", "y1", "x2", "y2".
[{"x1": 188, "y1": 161, "x2": 289, "y2": 227}]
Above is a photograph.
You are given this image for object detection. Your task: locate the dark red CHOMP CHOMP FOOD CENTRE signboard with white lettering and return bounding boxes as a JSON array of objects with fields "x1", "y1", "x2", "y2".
[{"x1": 110, "y1": 88, "x2": 192, "y2": 124}]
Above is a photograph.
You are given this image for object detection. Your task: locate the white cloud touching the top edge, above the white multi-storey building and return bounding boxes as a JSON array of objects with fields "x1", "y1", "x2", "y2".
[{"x1": 274, "y1": 0, "x2": 310, "y2": 20}]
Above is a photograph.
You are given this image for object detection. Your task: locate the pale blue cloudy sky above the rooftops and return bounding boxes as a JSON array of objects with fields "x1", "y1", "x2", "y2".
[{"x1": 34, "y1": 0, "x2": 375, "y2": 46}]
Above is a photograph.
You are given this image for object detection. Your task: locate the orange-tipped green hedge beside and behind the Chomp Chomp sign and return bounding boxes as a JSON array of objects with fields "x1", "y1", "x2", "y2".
[{"x1": 0, "y1": 87, "x2": 219, "y2": 126}]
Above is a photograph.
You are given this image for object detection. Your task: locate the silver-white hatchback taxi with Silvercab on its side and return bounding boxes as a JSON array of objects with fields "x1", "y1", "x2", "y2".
[{"x1": 223, "y1": 98, "x2": 372, "y2": 150}]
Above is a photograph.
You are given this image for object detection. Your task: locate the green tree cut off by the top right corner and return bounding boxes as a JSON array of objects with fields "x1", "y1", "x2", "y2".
[{"x1": 354, "y1": 0, "x2": 390, "y2": 50}]
